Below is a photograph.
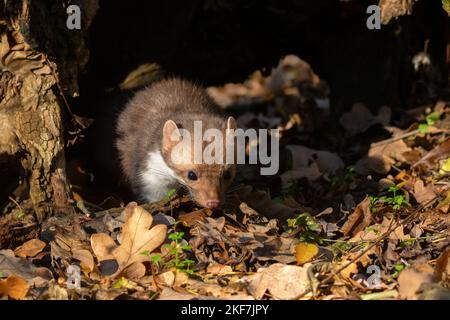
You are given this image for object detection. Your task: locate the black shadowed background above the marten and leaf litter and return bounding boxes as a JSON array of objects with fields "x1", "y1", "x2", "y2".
[{"x1": 80, "y1": 0, "x2": 449, "y2": 114}]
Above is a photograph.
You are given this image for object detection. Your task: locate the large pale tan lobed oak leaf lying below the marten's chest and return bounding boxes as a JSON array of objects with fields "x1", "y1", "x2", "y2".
[{"x1": 91, "y1": 206, "x2": 167, "y2": 277}]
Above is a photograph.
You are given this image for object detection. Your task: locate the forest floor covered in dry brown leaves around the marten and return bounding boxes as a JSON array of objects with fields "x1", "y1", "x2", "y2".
[{"x1": 0, "y1": 56, "x2": 450, "y2": 300}]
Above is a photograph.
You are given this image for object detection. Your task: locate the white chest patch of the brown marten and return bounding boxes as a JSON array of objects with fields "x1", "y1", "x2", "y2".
[{"x1": 141, "y1": 151, "x2": 178, "y2": 202}]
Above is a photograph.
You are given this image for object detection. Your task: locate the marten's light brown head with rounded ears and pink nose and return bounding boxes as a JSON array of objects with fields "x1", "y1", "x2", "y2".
[{"x1": 162, "y1": 117, "x2": 236, "y2": 208}]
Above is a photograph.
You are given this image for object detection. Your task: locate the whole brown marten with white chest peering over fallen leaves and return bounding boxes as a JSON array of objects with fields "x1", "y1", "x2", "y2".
[{"x1": 115, "y1": 79, "x2": 236, "y2": 208}]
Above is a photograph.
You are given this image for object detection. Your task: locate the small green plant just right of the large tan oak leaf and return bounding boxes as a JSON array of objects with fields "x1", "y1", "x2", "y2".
[{"x1": 142, "y1": 232, "x2": 196, "y2": 274}]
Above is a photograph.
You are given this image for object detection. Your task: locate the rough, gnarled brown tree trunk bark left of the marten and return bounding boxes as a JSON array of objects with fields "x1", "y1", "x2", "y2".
[{"x1": 0, "y1": 0, "x2": 97, "y2": 221}]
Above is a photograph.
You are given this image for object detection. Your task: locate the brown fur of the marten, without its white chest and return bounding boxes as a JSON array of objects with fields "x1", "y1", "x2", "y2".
[{"x1": 116, "y1": 79, "x2": 235, "y2": 206}]
